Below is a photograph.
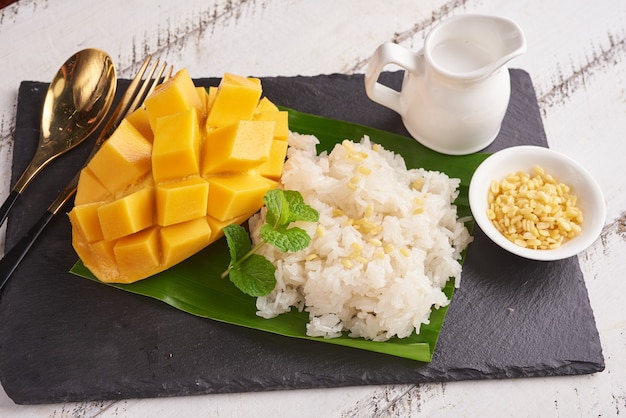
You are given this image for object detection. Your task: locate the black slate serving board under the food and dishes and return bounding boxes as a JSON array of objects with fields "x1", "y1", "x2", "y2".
[{"x1": 0, "y1": 70, "x2": 604, "y2": 404}]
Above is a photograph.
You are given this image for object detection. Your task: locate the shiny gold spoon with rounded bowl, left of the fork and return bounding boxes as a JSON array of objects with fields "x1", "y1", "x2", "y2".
[{"x1": 0, "y1": 48, "x2": 117, "y2": 226}]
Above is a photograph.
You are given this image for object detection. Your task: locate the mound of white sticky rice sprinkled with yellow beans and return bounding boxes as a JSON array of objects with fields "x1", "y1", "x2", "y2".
[{"x1": 250, "y1": 133, "x2": 471, "y2": 341}]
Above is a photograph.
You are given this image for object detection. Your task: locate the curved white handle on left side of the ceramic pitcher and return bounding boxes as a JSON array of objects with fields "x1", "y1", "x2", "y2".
[{"x1": 365, "y1": 42, "x2": 421, "y2": 114}]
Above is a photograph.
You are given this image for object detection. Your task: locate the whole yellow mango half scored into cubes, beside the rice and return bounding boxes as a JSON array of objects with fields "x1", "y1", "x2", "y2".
[{"x1": 69, "y1": 70, "x2": 286, "y2": 283}]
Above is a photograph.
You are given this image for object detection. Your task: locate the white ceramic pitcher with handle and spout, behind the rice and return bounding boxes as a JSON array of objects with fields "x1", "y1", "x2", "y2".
[{"x1": 365, "y1": 15, "x2": 526, "y2": 155}]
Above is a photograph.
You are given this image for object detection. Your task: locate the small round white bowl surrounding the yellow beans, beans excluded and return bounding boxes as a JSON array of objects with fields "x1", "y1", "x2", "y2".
[{"x1": 469, "y1": 146, "x2": 606, "y2": 261}]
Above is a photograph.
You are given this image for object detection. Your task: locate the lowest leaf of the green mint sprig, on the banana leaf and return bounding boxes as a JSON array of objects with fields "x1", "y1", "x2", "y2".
[{"x1": 224, "y1": 254, "x2": 276, "y2": 297}]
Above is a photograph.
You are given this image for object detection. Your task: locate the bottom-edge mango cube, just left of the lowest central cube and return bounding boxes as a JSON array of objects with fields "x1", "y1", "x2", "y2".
[{"x1": 113, "y1": 228, "x2": 161, "y2": 283}]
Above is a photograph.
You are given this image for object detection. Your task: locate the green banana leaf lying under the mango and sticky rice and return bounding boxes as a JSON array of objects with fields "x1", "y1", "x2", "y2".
[{"x1": 71, "y1": 108, "x2": 487, "y2": 362}]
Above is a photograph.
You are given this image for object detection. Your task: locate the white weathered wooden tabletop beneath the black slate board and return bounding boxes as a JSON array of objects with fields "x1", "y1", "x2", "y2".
[{"x1": 0, "y1": 0, "x2": 626, "y2": 417}]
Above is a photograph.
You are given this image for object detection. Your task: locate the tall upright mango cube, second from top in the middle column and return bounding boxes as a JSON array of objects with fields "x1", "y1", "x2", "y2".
[{"x1": 152, "y1": 109, "x2": 200, "y2": 183}]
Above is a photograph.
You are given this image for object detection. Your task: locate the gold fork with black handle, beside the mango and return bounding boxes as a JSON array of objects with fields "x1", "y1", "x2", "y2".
[{"x1": 0, "y1": 56, "x2": 173, "y2": 290}]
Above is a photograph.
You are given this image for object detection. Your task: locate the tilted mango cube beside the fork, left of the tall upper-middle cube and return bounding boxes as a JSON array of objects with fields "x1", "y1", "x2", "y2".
[{"x1": 87, "y1": 119, "x2": 152, "y2": 195}]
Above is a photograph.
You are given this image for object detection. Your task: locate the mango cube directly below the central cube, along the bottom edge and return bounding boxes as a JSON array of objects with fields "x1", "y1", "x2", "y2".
[{"x1": 161, "y1": 218, "x2": 212, "y2": 266}]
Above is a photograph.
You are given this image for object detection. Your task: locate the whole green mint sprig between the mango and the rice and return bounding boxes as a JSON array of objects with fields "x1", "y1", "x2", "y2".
[{"x1": 222, "y1": 189, "x2": 319, "y2": 297}]
